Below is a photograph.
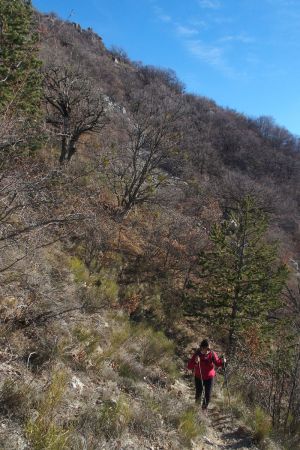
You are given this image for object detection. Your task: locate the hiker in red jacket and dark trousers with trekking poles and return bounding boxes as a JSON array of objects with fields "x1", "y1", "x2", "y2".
[{"x1": 187, "y1": 339, "x2": 226, "y2": 410}]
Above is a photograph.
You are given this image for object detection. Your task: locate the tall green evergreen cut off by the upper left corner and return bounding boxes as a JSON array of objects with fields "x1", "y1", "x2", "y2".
[{"x1": 0, "y1": 0, "x2": 41, "y2": 117}]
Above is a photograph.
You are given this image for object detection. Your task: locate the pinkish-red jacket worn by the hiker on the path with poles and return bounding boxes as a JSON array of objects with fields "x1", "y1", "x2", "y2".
[{"x1": 187, "y1": 350, "x2": 223, "y2": 380}]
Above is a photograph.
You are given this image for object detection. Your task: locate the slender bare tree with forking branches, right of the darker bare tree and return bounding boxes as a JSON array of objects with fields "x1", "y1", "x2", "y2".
[{"x1": 104, "y1": 84, "x2": 183, "y2": 214}]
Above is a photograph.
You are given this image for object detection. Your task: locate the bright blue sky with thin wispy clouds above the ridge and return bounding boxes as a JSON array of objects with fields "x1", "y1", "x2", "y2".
[{"x1": 33, "y1": 0, "x2": 300, "y2": 135}]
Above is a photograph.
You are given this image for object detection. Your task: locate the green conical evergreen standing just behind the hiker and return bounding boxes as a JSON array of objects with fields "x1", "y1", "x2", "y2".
[{"x1": 189, "y1": 196, "x2": 287, "y2": 355}]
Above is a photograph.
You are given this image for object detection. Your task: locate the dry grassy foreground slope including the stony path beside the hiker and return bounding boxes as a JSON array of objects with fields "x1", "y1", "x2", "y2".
[{"x1": 0, "y1": 246, "x2": 279, "y2": 450}]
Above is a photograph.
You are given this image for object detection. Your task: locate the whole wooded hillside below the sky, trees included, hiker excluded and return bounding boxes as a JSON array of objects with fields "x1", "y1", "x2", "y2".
[{"x1": 0, "y1": 0, "x2": 300, "y2": 450}]
